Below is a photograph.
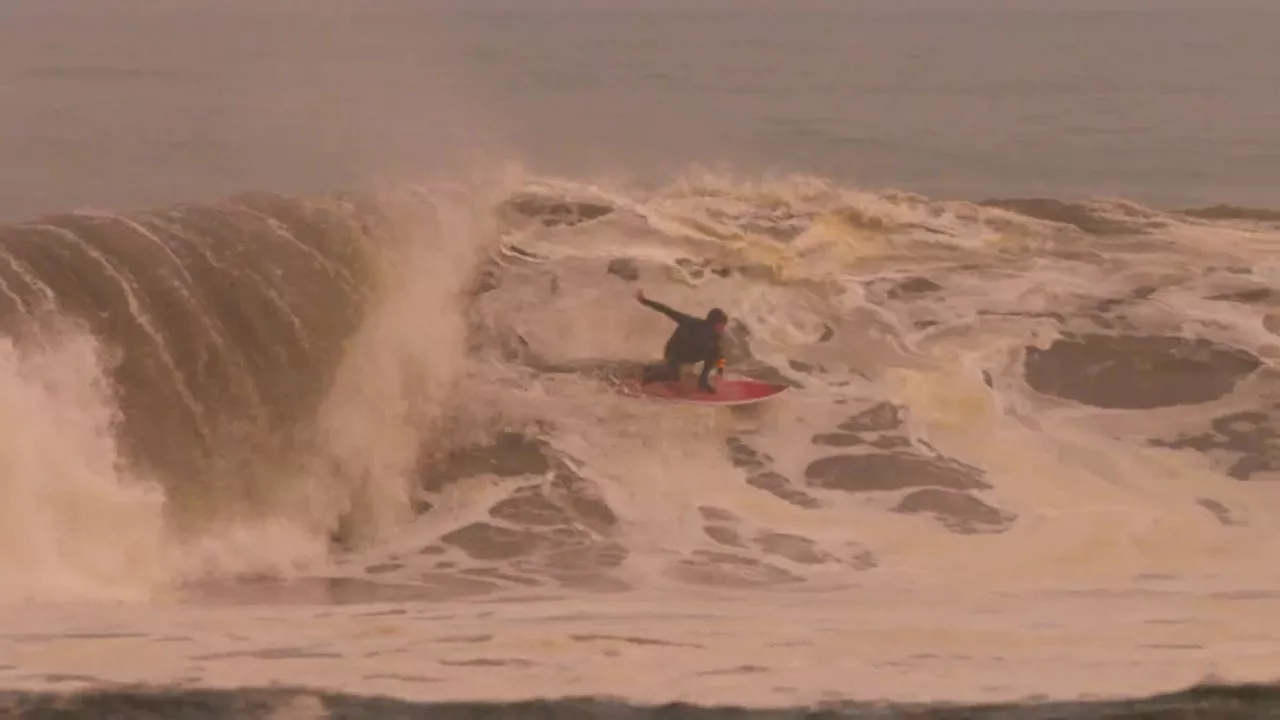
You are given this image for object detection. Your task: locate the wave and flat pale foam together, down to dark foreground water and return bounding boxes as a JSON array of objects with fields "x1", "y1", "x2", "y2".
[{"x1": 0, "y1": 173, "x2": 1280, "y2": 716}]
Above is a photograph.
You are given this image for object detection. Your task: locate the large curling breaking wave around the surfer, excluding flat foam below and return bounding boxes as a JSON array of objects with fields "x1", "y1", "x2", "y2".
[{"x1": 0, "y1": 174, "x2": 1280, "y2": 600}]
